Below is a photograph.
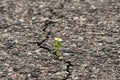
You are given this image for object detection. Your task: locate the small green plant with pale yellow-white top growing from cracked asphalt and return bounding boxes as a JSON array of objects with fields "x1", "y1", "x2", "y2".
[{"x1": 54, "y1": 38, "x2": 62, "y2": 57}]
